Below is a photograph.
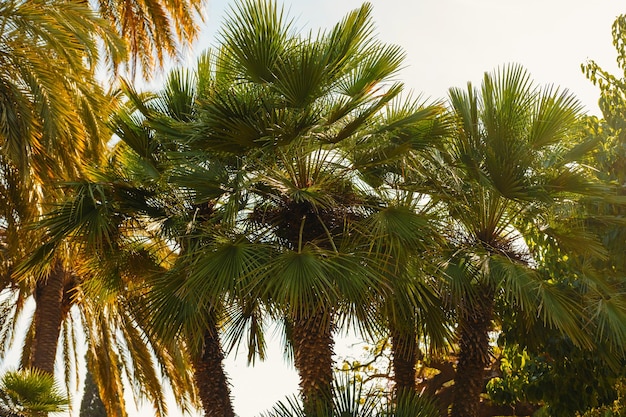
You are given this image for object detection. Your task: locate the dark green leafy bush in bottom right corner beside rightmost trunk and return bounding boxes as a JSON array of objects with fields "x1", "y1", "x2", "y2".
[{"x1": 487, "y1": 329, "x2": 624, "y2": 417}]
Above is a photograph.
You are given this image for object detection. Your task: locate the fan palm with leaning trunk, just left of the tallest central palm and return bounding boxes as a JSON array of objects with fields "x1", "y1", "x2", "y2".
[{"x1": 33, "y1": 56, "x2": 249, "y2": 416}]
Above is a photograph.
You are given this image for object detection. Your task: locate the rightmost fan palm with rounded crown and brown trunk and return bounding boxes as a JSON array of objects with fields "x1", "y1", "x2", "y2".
[{"x1": 432, "y1": 65, "x2": 606, "y2": 417}]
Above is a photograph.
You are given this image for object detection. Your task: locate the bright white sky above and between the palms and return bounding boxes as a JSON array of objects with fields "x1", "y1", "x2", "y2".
[{"x1": 12, "y1": 0, "x2": 626, "y2": 417}]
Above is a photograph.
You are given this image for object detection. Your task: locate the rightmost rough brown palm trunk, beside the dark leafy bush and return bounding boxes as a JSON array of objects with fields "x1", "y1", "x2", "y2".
[{"x1": 451, "y1": 289, "x2": 493, "y2": 417}]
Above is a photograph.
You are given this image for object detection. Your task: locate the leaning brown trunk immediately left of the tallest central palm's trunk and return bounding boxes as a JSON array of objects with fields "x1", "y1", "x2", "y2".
[{"x1": 194, "y1": 322, "x2": 235, "y2": 417}]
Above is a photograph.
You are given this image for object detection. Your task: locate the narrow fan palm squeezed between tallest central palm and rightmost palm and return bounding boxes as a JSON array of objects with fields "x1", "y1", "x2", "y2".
[{"x1": 352, "y1": 100, "x2": 450, "y2": 394}]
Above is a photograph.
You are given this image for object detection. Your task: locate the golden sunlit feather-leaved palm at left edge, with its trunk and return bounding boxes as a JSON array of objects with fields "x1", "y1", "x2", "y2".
[{"x1": 0, "y1": 0, "x2": 120, "y2": 373}]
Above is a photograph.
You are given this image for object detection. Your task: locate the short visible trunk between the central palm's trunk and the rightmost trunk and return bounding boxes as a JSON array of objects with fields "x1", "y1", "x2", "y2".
[{"x1": 390, "y1": 325, "x2": 418, "y2": 393}]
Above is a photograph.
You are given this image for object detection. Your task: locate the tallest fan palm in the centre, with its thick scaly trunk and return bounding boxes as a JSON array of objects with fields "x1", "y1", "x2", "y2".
[{"x1": 182, "y1": 1, "x2": 444, "y2": 416}]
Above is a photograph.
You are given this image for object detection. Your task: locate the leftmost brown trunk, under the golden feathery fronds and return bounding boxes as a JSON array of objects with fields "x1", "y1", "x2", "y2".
[{"x1": 30, "y1": 262, "x2": 67, "y2": 375}]
